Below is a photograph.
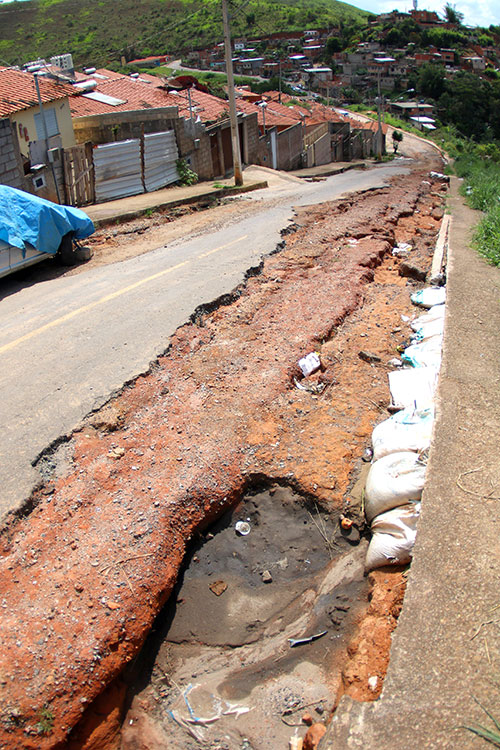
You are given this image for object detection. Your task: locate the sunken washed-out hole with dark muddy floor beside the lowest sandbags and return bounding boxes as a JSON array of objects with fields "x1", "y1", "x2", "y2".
[{"x1": 118, "y1": 488, "x2": 367, "y2": 750}]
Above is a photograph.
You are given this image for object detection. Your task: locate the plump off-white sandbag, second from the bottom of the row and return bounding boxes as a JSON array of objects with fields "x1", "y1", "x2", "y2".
[{"x1": 365, "y1": 451, "x2": 427, "y2": 521}]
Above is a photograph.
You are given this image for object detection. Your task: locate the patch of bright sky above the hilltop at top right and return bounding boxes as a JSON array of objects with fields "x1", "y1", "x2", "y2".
[{"x1": 358, "y1": 0, "x2": 500, "y2": 28}]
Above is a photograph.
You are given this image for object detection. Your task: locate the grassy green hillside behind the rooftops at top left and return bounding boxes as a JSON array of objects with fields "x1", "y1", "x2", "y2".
[{"x1": 0, "y1": 0, "x2": 368, "y2": 66}]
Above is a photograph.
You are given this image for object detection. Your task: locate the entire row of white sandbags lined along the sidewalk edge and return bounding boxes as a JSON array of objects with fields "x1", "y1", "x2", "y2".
[{"x1": 365, "y1": 287, "x2": 446, "y2": 570}]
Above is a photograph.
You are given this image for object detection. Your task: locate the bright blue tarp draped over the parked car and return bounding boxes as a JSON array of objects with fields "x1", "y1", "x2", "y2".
[{"x1": 0, "y1": 185, "x2": 94, "y2": 254}]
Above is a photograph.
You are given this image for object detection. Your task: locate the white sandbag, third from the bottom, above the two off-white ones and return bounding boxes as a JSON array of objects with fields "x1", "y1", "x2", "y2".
[{"x1": 372, "y1": 406, "x2": 434, "y2": 461}]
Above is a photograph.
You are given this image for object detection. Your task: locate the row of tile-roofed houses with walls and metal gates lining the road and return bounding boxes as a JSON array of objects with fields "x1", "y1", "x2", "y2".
[{"x1": 0, "y1": 61, "x2": 386, "y2": 205}]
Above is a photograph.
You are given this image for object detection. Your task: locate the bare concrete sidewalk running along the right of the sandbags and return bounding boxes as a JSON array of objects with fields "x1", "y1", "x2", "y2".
[{"x1": 320, "y1": 178, "x2": 500, "y2": 750}]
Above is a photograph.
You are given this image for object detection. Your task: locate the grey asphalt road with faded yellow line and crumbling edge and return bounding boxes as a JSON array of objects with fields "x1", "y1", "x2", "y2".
[{"x1": 0, "y1": 162, "x2": 408, "y2": 516}]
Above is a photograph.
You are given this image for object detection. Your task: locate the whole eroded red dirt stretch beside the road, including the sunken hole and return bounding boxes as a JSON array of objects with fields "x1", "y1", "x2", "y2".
[{"x1": 0, "y1": 157, "x2": 444, "y2": 750}]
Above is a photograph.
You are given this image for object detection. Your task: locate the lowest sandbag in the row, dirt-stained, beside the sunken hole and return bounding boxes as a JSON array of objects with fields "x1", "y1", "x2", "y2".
[{"x1": 365, "y1": 503, "x2": 420, "y2": 571}]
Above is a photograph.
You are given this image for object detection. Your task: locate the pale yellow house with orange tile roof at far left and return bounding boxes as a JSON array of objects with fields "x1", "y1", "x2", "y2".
[{"x1": 0, "y1": 68, "x2": 75, "y2": 160}]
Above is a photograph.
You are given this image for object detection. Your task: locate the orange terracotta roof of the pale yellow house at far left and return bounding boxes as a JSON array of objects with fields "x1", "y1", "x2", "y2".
[{"x1": 0, "y1": 68, "x2": 75, "y2": 117}]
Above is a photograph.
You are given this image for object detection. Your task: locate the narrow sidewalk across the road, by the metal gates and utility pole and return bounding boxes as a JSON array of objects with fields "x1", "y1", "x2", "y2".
[{"x1": 83, "y1": 174, "x2": 267, "y2": 228}]
